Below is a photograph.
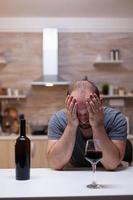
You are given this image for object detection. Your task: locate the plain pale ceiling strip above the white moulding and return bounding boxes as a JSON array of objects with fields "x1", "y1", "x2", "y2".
[{"x1": 0, "y1": 0, "x2": 133, "y2": 18}]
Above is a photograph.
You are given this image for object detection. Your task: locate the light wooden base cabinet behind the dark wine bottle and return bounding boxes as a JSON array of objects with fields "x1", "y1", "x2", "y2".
[{"x1": 0, "y1": 136, "x2": 48, "y2": 168}]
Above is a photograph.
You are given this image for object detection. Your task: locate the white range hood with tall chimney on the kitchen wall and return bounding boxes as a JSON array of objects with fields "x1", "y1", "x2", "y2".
[{"x1": 31, "y1": 28, "x2": 70, "y2": 86}]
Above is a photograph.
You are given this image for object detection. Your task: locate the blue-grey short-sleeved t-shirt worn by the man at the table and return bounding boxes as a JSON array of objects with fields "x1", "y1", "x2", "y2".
[{"x1": 48, "y1": 107, "x2": 127, "y2": 167}]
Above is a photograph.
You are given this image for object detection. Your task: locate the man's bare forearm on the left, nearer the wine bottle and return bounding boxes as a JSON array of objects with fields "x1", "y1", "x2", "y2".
[{"x1": 48, "y1": 125, "x2": 77, "y2": 169}]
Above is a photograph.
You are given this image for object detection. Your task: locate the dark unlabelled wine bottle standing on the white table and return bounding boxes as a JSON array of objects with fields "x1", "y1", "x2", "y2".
[{"x1": 15, "y1": 114, "x2": 30, "y2": 180}]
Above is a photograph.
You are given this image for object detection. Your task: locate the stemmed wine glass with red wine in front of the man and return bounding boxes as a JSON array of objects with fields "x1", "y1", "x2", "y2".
[{"x1": 85, "y1": 139, "x2": 102, "y2": 189}]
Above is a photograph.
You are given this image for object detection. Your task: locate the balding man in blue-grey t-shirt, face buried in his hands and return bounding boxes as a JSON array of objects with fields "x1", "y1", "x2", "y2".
[{"x1": 47, "y1": 80, "x2": 127, "y2": 170}]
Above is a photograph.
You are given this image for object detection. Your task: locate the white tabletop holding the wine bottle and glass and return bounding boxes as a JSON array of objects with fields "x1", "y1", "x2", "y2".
[{"x1": 0, "y1": 167, "x2": 133, "y2": 200}]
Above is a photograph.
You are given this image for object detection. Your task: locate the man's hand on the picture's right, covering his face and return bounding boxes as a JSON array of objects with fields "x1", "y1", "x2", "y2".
[{"x1": 86, "y1": 94, "x2": 104, "y2": 127}]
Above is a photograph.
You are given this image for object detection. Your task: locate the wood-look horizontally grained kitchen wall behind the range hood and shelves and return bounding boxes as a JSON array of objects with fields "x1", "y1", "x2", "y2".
[{"x1": 0, "y1": 32, "x2": 133, "y2": 132}]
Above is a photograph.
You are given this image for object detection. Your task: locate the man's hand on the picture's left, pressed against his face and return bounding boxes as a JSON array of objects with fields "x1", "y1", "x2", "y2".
[{"x1": 65, "y1": 95, "x2": 79, "y2": 127}]
